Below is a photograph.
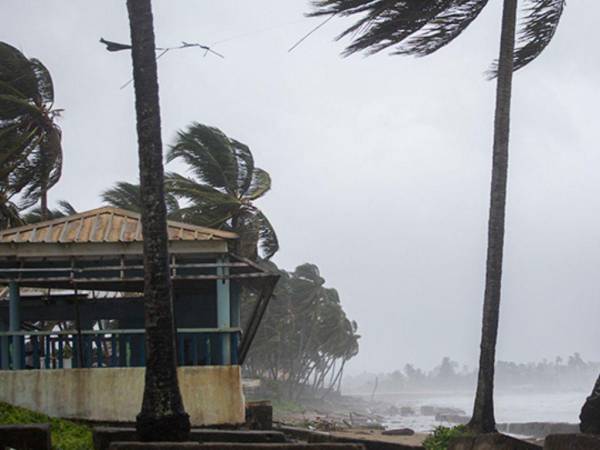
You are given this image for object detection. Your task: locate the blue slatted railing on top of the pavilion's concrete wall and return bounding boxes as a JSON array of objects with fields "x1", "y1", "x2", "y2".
[{"x1": 0, "y1": 328, "x2": 241, "y2": 370}]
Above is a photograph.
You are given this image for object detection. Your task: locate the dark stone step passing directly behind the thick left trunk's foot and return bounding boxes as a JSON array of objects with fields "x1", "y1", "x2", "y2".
[{"x1": 93, "y1": 427, "x2": 286, "y2": 450}]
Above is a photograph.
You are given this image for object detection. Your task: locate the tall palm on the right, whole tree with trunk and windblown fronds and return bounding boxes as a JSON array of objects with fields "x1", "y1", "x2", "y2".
[{"x1": 312, "y1": 0, "x2": 565, "y2": 432}]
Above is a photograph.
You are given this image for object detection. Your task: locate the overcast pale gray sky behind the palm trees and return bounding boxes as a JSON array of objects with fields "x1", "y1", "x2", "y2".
[{"x1": 0, "y1": 0, "x2": 600, "y2": 373}]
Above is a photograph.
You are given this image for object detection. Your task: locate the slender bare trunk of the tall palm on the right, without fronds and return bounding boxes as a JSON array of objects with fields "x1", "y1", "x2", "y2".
[{"x1": 469, "y1": 0, "x2": 517, "y2": 433}]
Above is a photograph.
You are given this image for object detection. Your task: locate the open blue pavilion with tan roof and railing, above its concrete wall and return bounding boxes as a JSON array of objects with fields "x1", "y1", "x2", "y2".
[{"x1": 0, "y1": 208, "x2": 277, "y2": 370}]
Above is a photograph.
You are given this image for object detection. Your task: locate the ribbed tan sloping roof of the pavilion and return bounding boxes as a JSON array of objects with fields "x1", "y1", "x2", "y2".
[{"x1": 0, "y1": 207, "x2": 238, "y2": 244}]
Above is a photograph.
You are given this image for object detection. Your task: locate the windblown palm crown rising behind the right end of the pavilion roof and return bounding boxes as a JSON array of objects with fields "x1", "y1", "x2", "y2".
[{"x1": 167, "y1": 123, "x2": 279, "y2": 259}]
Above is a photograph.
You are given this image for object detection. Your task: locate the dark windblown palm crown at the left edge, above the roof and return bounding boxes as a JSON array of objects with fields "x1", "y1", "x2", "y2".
[{"x1": 0, "y1": 42, "x2": 62, "y2": 218}]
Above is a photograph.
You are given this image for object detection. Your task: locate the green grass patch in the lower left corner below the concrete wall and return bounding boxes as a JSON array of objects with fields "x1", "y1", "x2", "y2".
[{"x1": 0, "y1": 402, "x2": 94, "y2": 450}]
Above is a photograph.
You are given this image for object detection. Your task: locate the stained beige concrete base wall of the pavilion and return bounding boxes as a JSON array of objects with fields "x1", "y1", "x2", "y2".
[{"x1": 0, "y1": 366, "x2": 245, "y2": 426}]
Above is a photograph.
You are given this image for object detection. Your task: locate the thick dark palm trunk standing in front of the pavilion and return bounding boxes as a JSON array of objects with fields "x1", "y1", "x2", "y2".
[{"x1": 127, "y1": 0, "x2": 190, "y2": 441}]
